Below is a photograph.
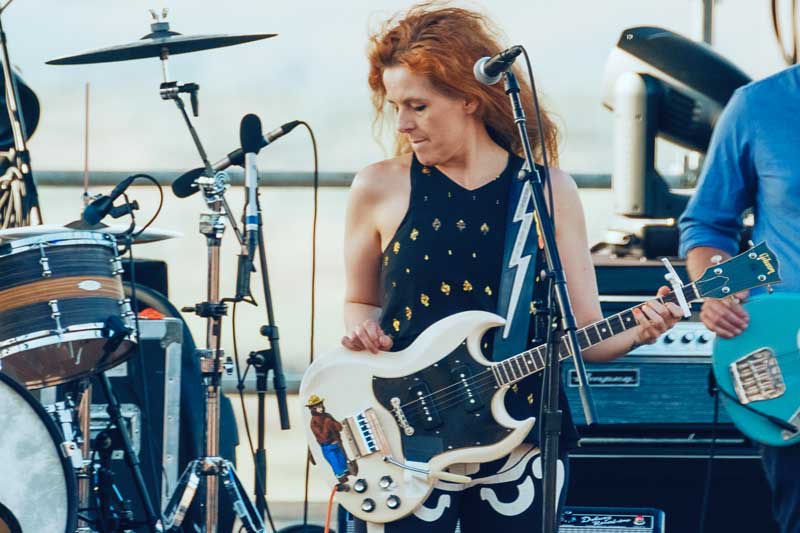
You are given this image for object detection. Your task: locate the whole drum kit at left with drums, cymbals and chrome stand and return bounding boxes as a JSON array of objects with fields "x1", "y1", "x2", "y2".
[{"x1": 0, "y1": 5, "x2": 288, "y2": 533}]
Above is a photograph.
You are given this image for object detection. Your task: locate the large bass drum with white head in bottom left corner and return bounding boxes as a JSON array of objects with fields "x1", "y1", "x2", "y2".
[{"x1": 0, "y1": 372, "x2": 78, "y2": 533}]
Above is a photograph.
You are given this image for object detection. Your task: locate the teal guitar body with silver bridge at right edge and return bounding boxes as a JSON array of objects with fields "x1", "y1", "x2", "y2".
[{"x1": 713, "y1": 293, "x2": 800, "y2": 446}]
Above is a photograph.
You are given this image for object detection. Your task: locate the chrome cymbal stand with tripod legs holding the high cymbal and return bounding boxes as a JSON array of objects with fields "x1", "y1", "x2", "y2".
[{"x1": 154, "y1": 35, "x2": 265, "y2": 533}]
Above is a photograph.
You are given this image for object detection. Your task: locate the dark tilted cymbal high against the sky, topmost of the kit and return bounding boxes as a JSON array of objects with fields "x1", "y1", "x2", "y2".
[{"x1": 47, "y1": 22, "x2": 277, "y2": 65}]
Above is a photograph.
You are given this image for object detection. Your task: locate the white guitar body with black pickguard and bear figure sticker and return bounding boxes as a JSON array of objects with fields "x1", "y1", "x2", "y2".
[{"x1": 300, "y1": 311, "x2": 534, "y2": 523}]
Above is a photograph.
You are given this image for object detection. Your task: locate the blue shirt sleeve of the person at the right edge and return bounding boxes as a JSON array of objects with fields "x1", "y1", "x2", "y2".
[{"x1": 678, "y1": 89, "x2": 756, "y2": 257}]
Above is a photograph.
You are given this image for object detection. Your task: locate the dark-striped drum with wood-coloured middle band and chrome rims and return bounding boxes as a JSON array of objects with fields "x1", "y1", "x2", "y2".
[{"x1": 0, "y1": 231, "x2": 135, "y2": 389}]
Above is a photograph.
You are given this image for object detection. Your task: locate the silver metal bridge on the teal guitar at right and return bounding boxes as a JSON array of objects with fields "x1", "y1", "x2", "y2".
[{"x1": 729, "y1": 348, "x2": 786, "y2": 404}]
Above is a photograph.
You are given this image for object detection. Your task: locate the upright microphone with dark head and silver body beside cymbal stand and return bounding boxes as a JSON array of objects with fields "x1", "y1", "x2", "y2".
[{"x1": 236, "y1": 114, "x2": 264, "y2": 300}]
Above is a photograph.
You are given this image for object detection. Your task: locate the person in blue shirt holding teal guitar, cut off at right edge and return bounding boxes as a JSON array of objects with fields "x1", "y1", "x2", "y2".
[{"x1": 679, "y1": 65, "x2": 800, "y2": 533}]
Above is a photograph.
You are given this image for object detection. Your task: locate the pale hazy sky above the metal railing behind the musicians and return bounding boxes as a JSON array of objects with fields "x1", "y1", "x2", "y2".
[{"x1": 3, "y1": 0, "x2": 788, "y2": 172}]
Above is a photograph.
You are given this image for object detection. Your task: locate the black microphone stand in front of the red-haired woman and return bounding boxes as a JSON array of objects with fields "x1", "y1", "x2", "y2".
[{"x1": 505, "y1": 70, "x2": 595, "y2": 533}]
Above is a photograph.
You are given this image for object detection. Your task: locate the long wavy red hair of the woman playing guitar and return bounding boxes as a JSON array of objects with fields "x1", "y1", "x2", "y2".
[{"x1": 367, "y1": 1, "x2": 558, "y2": 165}]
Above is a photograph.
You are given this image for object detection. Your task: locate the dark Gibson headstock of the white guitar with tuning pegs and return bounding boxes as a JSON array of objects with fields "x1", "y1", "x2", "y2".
[{"x1": 695, "y1": 242, "x2": 781, "y2": 298}]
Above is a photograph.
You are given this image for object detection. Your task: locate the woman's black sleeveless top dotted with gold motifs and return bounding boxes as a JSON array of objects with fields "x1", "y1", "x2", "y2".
[{"x1": 380, "y1": 154, "x2": 578, "y2": 446}]
